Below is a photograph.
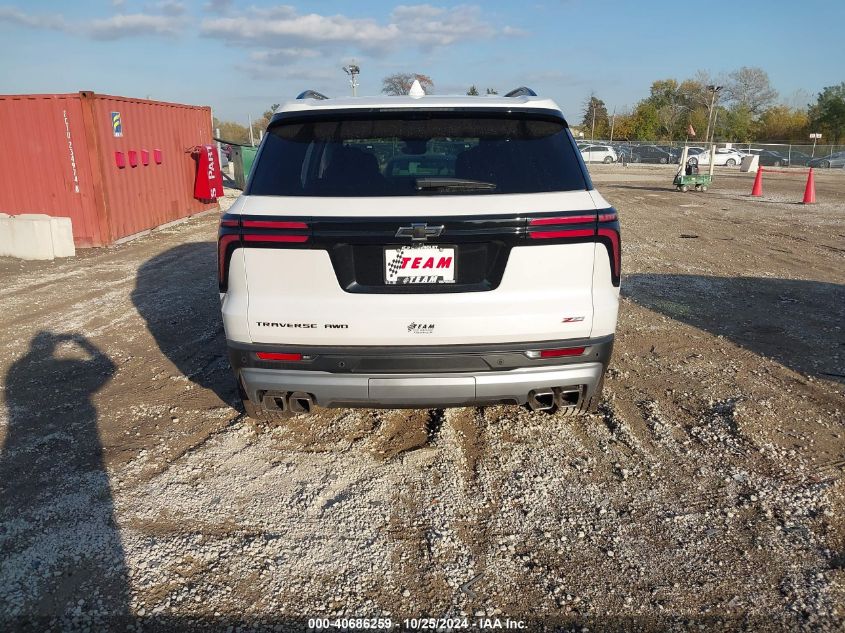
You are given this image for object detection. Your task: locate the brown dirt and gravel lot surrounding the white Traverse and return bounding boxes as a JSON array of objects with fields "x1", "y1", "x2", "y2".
[{"x1": 0, "y1": 166, "x2": 845, "y2": 631}]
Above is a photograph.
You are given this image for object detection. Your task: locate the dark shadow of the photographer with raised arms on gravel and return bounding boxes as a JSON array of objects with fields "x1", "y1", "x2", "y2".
[{"x1": 0, "y1": 332, "x2": 129, "y2": 630}]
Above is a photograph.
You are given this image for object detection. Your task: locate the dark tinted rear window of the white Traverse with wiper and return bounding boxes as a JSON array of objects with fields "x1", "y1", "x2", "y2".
[{"x1": 248, "y1": 112, "x2": 587, "y2": 196}]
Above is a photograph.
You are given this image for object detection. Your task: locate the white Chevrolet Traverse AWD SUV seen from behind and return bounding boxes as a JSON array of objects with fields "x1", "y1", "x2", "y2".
[{"x1": 218, "y1": 88, "x2": 620, "y2": 418}]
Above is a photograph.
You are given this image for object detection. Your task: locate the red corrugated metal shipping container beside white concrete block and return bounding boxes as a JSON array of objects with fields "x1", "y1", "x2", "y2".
[{"x1": 0, "y1": 92, "x2": 217, "y2": 247}]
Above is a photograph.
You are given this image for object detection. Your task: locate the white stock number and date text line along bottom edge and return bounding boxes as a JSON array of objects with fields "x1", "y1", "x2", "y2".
[{"x1": 308, "y1": 617, "x2": 527, "y2": 631}]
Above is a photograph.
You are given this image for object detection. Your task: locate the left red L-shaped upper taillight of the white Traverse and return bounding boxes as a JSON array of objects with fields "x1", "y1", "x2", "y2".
[{"x1": 217, "y1": 216, "x2": 311, "y2": 292}]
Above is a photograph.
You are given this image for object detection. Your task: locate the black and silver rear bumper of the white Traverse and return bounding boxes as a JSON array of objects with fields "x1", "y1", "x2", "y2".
[{"x1": 230, "y1": 337, "x2": 613, "y2": 407}]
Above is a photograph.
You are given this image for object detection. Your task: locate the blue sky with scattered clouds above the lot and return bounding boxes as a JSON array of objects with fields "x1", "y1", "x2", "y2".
[{"x1": 0, "y1": 0, "x2": 845, "y2": 124}]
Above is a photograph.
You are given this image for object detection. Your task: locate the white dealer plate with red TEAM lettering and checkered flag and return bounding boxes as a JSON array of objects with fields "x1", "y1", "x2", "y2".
[{"x1": 384, "y1": 244, "x2": 456, "y2": 285}]
